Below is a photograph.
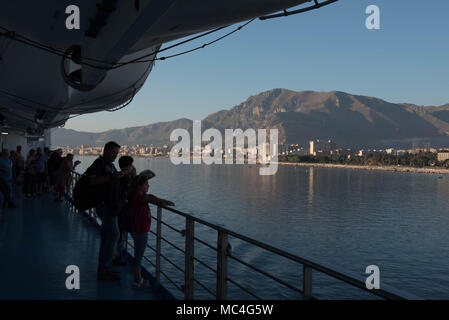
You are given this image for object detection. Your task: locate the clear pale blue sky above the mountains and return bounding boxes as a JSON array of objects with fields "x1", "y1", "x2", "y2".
[{"x1": 65, "y1": 0, "x2": 449, "y2": 132}]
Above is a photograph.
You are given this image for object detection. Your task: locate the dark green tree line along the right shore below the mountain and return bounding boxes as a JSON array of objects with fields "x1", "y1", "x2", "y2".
[{"x1": 279, "y1": 152, "x2": 449, "y2": 169}]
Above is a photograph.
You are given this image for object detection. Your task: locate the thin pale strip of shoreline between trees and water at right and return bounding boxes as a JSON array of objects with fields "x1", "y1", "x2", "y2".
[{"x1": 277, "y1": 162, "x2": 449, "y2": 174}]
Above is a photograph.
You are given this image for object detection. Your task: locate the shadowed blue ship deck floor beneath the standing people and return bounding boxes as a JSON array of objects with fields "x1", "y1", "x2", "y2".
[{"x1": 0, "y1": 189, "x2": 170, "y2": 300}]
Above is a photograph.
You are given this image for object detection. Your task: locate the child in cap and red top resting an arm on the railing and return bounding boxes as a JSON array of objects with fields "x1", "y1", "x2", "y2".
[{"x1": 129, "y1": 170, "x2": 175, "y2": 288}]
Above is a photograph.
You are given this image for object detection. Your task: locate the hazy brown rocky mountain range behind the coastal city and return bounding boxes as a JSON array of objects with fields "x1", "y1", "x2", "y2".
[{"x1": 52, "y1": 89, "x2": 449, "y2": 147}]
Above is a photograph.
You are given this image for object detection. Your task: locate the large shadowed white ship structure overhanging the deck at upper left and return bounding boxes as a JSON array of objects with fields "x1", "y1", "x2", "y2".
[{"x1": 0, "y1": 0, "x2": 337, "y2": 152}]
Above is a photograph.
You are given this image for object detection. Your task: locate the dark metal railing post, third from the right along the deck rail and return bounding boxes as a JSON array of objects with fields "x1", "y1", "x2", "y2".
[{"x1": 184, "y1": 218, "x2": 195, "y2": 300}]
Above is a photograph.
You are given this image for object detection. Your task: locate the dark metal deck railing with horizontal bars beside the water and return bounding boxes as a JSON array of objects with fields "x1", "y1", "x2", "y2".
[{"x1": 67, "y1": 172, "x2": 420, "y2": 300}]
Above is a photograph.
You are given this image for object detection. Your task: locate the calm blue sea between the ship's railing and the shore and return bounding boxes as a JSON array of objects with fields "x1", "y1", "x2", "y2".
[{"x1": 77, "y1": 156, "x2": 449, "y2": 299}]
